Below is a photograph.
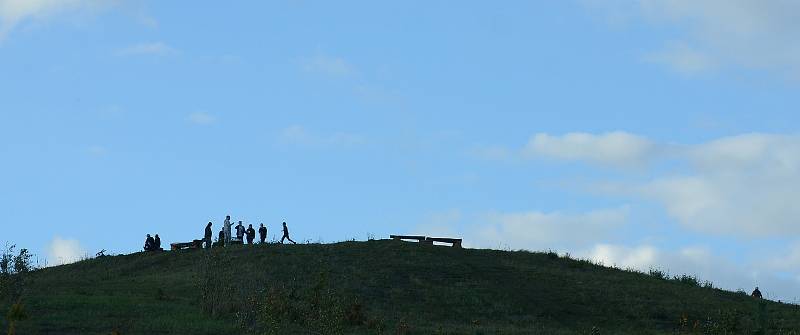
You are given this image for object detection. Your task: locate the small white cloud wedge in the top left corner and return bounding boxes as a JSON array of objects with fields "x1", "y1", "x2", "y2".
[{"x1": 0, "y1": 0, "x2": 117, "y2": 40}]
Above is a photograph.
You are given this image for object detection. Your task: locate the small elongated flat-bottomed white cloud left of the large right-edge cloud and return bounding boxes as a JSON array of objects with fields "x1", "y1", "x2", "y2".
[{"x1": 523, "y1": 132, "x2": 658, "y2": 167}]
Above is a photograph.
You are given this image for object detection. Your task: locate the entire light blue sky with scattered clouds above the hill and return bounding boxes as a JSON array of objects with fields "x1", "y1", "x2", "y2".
[{"x1": 0, "y1": 0, "x2": 800, "y2": 300}]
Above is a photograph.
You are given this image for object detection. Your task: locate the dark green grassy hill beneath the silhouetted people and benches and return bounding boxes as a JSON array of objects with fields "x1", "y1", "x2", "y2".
[{"x1": 3, "y1": 241, "x2": 800, "y2": 334}]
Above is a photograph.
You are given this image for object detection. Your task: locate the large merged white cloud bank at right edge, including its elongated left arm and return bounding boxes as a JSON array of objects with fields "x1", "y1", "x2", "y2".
[{"x1": 512, "y1": 132, "x2": 800, "y2": 238}]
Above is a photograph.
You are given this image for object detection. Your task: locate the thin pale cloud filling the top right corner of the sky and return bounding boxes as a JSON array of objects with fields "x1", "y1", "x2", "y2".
[{"x1": 588, "y1": 0, "x2": 800, "y2": 77}]
